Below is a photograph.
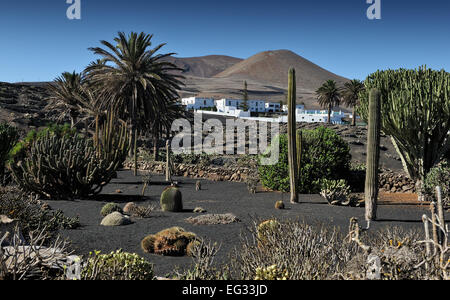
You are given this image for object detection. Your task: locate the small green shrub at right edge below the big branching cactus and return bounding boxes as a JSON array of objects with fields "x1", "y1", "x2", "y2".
[{"x1": 424, "y1": 161, "x2": 450, "y2": 207}]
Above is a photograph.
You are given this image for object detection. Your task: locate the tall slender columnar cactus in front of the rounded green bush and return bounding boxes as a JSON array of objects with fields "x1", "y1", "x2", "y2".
[{"x1": 287, "y1": 68, "x2": 298, "y2": 203}]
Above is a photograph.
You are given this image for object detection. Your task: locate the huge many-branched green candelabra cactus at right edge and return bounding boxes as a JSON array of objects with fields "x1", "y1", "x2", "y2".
[{"x1": 358, "y1": 67, "x2": 450, "y2": 196}]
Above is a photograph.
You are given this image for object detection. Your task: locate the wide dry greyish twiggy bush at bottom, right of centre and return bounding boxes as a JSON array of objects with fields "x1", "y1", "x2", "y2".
[{"x1": 231, "y1": 221, "x2": 358, "y2": 280}]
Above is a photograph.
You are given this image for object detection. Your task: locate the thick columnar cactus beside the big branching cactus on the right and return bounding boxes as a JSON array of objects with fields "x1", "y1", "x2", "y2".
[{"x1": 365, "y1": 89, "x2": 381, "y2": 222}]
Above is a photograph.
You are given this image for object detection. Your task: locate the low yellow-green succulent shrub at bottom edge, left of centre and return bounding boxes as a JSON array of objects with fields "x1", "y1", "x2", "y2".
[{"x1": 81, "y1": 250, "x2": 154, "y2": 280}]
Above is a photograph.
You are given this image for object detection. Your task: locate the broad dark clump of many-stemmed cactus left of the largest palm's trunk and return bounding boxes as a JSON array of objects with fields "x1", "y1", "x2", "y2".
[{"x1": 9, "y1": 125, "x2": 128, "y2": 199}]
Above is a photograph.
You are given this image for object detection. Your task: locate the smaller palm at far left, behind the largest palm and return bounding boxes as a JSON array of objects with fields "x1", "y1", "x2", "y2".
[{"x1": 47, "y1": 71, "x2": 85, "y2": 127}]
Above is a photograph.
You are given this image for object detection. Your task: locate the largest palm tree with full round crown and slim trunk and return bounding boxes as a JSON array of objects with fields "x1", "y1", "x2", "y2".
[{"x1": 86, "y1": 32, "x2": 183, "y2": 175}]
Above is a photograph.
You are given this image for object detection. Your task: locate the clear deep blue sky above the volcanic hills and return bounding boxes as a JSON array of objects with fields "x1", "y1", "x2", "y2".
[{"x1": 0, "y1": 0, "x2": 450, "y2": 82}]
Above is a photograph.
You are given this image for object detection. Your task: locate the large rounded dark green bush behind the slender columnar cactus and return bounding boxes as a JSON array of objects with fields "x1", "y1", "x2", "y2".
[{"x1": 258, "y1": 126, "x2": 351, "y2": 193}]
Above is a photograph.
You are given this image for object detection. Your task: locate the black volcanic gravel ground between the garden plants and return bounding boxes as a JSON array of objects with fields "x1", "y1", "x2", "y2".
[{"x1": 48, "y1": 170, "x2": 449, "y2": 276}]
